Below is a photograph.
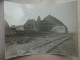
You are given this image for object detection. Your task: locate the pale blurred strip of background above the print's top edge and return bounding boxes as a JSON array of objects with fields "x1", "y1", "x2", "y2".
[{"x1": 5, "y1": 0, "x2": 76, "y2": 4}]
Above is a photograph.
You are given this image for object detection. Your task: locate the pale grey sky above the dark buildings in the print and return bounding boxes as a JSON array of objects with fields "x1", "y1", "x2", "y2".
[{"x1": 4, "y1": 1, "x2": 78, "y2": 32}]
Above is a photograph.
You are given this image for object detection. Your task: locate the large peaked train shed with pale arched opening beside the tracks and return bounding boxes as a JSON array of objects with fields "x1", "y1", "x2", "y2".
[{"x1": 41, "y1": 15, "x2": 68, "y2": 33}]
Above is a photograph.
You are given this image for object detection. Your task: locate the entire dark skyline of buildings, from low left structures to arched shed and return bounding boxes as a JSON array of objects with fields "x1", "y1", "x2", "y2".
[{"x1": 5, "y1": 15, "x2": 68, "y2": 35}]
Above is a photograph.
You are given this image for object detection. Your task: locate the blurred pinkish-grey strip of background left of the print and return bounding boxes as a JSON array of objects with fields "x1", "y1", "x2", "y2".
[{"x1": 0, "y1": 1, "x2": 4, "y2": 60}]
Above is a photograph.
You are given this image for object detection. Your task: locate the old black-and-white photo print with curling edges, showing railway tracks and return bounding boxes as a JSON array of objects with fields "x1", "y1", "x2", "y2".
[{"x1": 4, "y1": 1, "x2": 78, "y2": 59}]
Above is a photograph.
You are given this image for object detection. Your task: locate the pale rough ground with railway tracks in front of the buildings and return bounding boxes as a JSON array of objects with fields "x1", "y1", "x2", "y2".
[{"x1": 5, "y1": 33, "x2": 76, "y2": 59}]
